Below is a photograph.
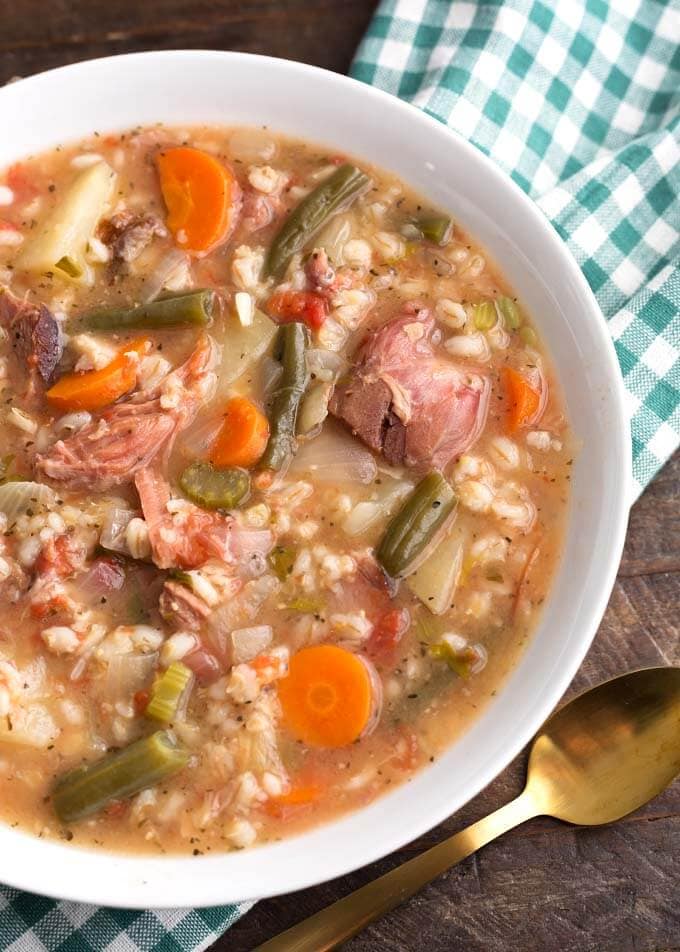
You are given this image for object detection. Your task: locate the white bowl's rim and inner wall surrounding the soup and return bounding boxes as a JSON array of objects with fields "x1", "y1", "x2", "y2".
[{"x1": 0, "y1": 50, "x2": 630, "y2": 908}]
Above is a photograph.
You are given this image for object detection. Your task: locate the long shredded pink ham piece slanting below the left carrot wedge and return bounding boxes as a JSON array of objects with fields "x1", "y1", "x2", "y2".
[{"x1": 36, "y1": 337, "x2": 215, "y2": 491}]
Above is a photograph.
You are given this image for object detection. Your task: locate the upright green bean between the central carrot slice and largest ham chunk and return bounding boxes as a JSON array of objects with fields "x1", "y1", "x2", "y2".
[{"x1": 260, "y1": 322, "x2": 309, "y2": 470}]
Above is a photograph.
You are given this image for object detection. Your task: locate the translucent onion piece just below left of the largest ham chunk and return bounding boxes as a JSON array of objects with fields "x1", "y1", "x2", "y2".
[{"x1": 289, "y1": 427, "x2": 378, "y2": 483}]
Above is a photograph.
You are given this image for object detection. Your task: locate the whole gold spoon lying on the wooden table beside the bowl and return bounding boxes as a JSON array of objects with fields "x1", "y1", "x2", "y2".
[{"x1": 259, "y1": 668, "x2": 680, "y2": 952}]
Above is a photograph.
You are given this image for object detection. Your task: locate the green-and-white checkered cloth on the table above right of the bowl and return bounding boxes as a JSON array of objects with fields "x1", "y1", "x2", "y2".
[{"x1": 351, "y1": 0, "x2": 680, "y2": 496}]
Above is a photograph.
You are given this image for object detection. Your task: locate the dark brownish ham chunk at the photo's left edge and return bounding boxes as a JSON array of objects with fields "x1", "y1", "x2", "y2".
[{"x1": 0, "y1": 289, "x2": 63, "y2": 394}]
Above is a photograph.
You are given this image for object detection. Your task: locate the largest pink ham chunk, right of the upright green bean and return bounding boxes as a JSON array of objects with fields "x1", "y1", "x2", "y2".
[{"x1": 330, "y1": 305, "x2": 490, "y2": 469}]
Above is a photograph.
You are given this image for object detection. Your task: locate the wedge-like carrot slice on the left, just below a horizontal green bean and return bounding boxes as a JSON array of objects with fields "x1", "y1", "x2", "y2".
[{"x1": 45, "y1": 337, "x2": 151, "y2": 410}]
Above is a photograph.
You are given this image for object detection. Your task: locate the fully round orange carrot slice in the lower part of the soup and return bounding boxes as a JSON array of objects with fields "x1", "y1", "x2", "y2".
[{"x1": 278, "y1": 645, "x2": 373, "y2": 747}]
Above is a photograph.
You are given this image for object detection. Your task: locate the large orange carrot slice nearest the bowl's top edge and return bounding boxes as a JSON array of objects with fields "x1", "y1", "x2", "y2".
[{"x1": 156, "y1": 146, "x2": 241, "y2": 254}]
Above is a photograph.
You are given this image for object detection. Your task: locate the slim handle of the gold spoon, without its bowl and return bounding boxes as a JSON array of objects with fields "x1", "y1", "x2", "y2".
[{"x1": 258, "y1": 790, "x2": 538, "y2": 952}]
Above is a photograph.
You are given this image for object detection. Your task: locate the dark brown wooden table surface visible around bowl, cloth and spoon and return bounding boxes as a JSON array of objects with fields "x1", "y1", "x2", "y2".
[{"x1": 0, "y1": 0, "x2": 680, "y2": 952}]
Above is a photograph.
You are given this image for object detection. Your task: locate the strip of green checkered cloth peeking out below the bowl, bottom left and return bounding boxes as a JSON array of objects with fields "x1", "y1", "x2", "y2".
[{"x1": 0, "y1": 886, "x2": 252, "y2": 952}]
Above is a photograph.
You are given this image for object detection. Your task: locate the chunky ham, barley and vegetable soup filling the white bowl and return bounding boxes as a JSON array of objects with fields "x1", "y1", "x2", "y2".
[{"x1": 0, "y1": 126, "x2": 573, "y2": 855}]
